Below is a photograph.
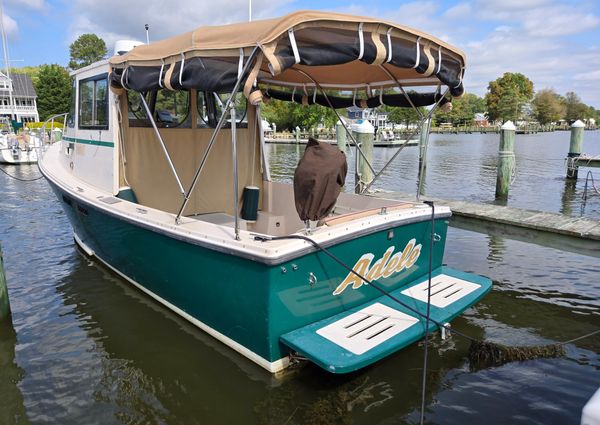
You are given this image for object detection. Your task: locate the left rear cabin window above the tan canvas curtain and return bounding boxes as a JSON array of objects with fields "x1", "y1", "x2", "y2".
[{"x1": 127, "y1": 89, "x2": 191, "y2": 128}]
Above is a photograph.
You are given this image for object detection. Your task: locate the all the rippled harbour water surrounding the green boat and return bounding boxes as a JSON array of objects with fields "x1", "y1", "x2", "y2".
[{"x1": 0, "y1": 133, "x2": 600, "y2": 425}]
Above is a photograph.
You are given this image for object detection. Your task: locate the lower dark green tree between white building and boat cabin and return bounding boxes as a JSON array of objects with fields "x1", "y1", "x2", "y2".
[{"x1": 35, "y1": 65, "x2": 71, "y2": 121}]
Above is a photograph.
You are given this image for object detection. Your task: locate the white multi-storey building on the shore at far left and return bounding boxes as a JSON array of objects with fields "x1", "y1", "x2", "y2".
[{"x1": 0, "y1": 72, "x2": 40, "y2": 122}]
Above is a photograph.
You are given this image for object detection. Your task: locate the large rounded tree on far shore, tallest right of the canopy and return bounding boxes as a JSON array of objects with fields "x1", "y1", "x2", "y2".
[{"x1": 485, "y1": 72, "x2": 533, "y2": 121}]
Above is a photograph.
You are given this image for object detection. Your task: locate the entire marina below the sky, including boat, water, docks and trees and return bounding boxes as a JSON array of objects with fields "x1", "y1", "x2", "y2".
[{"x1": 0, "y1": 1, "x2": 600, "y2": 425}]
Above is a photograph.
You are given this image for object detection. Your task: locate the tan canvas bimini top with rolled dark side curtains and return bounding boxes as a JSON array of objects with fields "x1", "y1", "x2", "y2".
[{"x1": 109, "y1": 11, "x2": 465, "y2": 96}]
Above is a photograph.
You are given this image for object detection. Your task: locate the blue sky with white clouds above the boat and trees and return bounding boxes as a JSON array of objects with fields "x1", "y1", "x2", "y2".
[{"x1": 0, "y1": 0, "x2": 600, "y2": 109}]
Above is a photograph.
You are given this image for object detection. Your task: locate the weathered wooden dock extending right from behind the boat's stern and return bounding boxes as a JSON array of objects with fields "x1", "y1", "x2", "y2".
[{"x1": 379, "y1": 193, "x2": 600, "y2": 257}]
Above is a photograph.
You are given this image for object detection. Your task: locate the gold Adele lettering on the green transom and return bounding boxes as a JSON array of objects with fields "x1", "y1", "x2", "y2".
[{"x1": 333, "y1": 239, "x2": 421, "y2": 295}]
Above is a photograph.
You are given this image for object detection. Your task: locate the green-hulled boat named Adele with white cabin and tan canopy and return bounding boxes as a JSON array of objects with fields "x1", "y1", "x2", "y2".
[{"x1": 38, "y1": 11, "x2": 491, "y2": 373}]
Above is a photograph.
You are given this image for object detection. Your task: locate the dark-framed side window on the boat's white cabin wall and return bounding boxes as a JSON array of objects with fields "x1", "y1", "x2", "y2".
[{"x1": 79, "y1": 74, "x2": 108, "y2": 130}]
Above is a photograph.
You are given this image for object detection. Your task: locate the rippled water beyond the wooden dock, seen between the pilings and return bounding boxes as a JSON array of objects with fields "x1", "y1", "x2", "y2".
[{"x1": 269, "y1": 131, "x2": 600, "y2": 219}]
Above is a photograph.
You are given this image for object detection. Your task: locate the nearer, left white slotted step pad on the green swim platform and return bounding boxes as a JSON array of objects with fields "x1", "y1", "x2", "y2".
[{"x1": 317, "y1": 303, "x2": 419, "y2": 355}]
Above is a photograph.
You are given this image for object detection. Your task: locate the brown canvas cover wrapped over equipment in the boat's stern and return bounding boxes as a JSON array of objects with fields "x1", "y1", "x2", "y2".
[{"x1": 294, "y1": 137, "x2": 348, "y2": 221}]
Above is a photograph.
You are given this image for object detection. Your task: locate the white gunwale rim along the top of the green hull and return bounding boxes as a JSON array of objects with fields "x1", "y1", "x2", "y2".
[{"x1": 40, "y1": 143, "x2": 450, "y2": 263}]
